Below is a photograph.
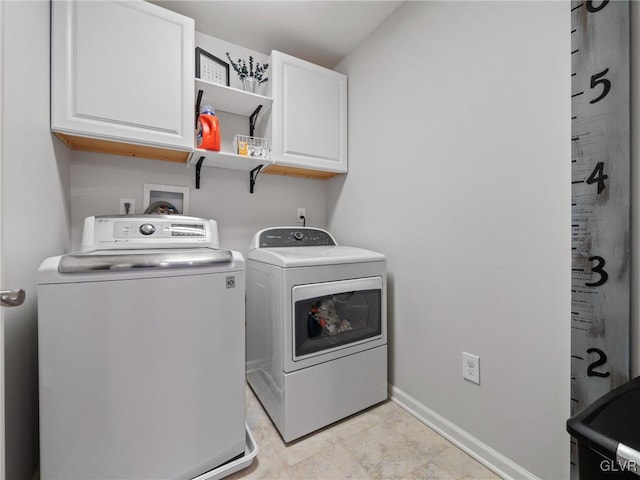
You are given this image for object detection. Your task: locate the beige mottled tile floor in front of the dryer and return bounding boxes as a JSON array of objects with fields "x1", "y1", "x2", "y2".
[{"x1": 226, "y1": 387, "x2": 499, "y2": 480}]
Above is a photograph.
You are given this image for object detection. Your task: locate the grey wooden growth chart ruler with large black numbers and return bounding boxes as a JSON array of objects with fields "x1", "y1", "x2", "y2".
[{"x1": 571, "y1": 0, "x2": 631, "y2": 477}]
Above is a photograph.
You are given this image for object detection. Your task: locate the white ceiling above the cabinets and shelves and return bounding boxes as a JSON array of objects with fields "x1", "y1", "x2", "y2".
[{"x1": 152, "y1": 0, "x2": 402, "y2": 68}]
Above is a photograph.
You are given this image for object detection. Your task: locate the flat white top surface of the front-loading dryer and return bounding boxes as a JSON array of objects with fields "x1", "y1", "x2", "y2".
[{"x1": 247, "y1": 245, "x2": 385, "y2": 267}]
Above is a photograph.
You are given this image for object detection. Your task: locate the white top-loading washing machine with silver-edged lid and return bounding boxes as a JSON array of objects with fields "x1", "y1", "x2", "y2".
[{"x1": 38, "y1": 215, "x2": 246, "y2": 480}]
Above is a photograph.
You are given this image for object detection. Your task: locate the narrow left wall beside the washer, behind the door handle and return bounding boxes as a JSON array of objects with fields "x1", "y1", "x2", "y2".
[{"x1": 0, "y1": 1, "x2": 70, "y2": 480}]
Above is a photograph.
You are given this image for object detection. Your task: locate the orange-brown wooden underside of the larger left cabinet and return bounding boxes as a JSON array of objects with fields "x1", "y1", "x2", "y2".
[{"x1": 53, "y1": 132, "x2": 191, "y2": 164}]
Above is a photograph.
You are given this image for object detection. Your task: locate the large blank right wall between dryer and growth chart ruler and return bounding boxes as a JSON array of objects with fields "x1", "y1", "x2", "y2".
[{"x1": 329, "y1": 1, "x2": 571, "y2": 478}]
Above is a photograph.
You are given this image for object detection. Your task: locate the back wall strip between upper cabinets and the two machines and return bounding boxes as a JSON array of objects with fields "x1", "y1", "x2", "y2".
[{"x1": 71, "y1": 152, "x2": 327, "y2": 255}]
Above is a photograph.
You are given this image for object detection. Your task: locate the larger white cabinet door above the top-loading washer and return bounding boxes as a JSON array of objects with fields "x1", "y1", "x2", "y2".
[{"x1": 51, "y1": 1, "x2": 194, "y2": 150}]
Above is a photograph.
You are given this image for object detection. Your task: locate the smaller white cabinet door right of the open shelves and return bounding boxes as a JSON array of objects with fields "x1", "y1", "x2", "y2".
[{"x1": 271, "y1": 51, "x2": 347, "y2": 173}]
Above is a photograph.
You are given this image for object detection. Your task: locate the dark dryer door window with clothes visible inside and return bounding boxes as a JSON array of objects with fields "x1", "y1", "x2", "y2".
[{"x1": 294, "y1": 289, "x2": 381, "y2": 357}]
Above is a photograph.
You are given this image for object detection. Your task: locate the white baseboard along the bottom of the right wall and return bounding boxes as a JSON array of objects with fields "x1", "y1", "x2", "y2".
[{"x1": 389, "y1": 385, "x2": 540, "y2": 480}]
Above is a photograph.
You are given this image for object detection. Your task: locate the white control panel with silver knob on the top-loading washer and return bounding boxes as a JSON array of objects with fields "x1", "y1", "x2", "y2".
[{"x1": 82, "y1": 215, "x2": 218, "y2": 251}]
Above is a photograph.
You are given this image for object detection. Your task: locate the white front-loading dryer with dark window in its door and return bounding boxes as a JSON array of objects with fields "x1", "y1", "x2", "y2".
[{"x1": 247, "y1": 227, "x2": 387, "y2": 442}]
